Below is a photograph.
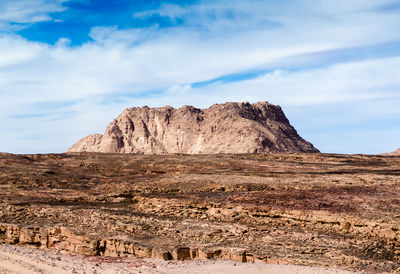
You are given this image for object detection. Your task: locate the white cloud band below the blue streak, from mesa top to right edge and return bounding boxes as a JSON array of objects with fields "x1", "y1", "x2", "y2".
[{"x1": 126, "y1": 57, "x2": 400, "y2": 109}]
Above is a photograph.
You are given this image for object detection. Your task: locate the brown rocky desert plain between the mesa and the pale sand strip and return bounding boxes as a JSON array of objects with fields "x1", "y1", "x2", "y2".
[{"x1": 0, "y1": 153, "x2": 400, "y2": 273}]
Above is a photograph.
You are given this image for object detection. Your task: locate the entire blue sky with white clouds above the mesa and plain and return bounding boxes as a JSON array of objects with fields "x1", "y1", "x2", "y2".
[{"x1": 0, "y1": 0, "x2": 400, "y2": 154}]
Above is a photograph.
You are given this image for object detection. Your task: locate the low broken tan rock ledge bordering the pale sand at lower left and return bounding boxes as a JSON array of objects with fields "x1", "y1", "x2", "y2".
[{"x1": 0, "y1": 223, "x2": 258, "y2": 262}]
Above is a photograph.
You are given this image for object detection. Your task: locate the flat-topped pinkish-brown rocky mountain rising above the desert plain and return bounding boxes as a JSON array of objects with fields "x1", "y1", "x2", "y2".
[{"x1": 67, "y1": 102, "x2": 319, "y2": 154}]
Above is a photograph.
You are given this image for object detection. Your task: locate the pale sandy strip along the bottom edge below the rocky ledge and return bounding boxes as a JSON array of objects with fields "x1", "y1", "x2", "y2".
[{"x1": 0, "y1": 245, "x2": 354, "y2": 274}]
